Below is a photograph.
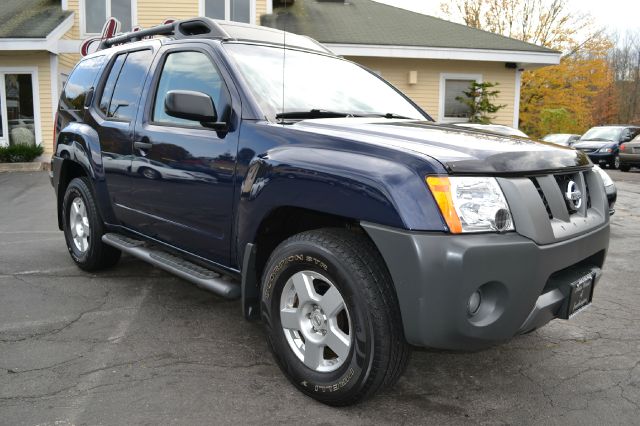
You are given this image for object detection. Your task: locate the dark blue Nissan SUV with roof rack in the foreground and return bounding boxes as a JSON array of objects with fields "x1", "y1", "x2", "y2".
[{"x1": 51, "y1": 18, "x2": 609, "y2": 405}]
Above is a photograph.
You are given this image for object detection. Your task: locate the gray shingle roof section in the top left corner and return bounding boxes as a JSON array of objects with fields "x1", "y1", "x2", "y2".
[{"x1": 0, "y1": 0, "x2": 71, "y2": 38}]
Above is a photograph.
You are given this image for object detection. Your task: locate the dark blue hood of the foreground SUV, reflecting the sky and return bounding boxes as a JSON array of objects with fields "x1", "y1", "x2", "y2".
[{"x1": 292, "y1": 118, "x2": 591, "y2": 175}]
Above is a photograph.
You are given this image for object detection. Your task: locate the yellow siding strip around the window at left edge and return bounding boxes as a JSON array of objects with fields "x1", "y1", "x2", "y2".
[{"x1": 0, "y1": 51, "x2": 53, "y2": 156}]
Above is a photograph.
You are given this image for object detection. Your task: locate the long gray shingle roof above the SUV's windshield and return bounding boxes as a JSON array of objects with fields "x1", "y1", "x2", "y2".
[{"x1": 261, "y1": 0, "x2": 555, "y2": 53}]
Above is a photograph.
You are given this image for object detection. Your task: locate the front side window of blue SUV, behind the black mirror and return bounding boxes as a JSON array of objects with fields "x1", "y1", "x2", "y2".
[{"x1": 151, "y1": 52, "x2": 228, "y2": 127}]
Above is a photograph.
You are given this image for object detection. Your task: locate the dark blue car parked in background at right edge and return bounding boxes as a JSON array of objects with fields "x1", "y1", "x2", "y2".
[{"x1": 573, "y1": 126, "x2": 640, "y2": 169}]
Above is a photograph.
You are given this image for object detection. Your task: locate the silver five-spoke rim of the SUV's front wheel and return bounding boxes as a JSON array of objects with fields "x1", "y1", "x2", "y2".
[{"x1": 280, "y1": 271, "x2": 351, "y2": 372}]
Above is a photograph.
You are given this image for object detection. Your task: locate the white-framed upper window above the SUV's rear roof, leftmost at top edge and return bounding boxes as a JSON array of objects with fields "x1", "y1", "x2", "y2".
[{"x1": 83, "y1": 0, "x2": 135, "y2": 34}]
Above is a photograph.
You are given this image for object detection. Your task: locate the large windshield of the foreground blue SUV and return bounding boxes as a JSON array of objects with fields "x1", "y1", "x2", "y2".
[{"x1": 225, "y1": 43, "x2": 426, "y2": 120}]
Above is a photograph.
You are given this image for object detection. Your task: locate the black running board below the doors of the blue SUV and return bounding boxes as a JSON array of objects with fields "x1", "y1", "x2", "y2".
[{"x1": 102, "y1": 233, "x2": 240, "y2": 299}]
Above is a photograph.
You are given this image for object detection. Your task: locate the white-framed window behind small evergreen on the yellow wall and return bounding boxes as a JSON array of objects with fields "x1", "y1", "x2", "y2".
[{"x1": 439, "y1": 74, "x2": 482, "y2": 122}]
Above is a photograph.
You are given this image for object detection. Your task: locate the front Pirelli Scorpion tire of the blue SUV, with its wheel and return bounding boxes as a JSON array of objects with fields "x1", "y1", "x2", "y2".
[{"x1": 261, "y1": 228, "x2": 410, "y2": 406}]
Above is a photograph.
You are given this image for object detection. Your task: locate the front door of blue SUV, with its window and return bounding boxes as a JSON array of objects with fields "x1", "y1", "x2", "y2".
[{"x1": 130, "y1": 48, "x2": 238, "y2": 264}]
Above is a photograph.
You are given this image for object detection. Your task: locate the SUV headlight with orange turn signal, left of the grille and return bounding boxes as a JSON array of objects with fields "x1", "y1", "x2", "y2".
[{"x1": 426, "y1": 176, "x2": 514, "y2": 234}]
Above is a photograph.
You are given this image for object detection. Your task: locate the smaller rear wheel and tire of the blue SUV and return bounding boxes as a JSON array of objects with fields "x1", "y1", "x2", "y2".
[{"x1": 62, "y1": 177, "x2": 122, "y2": 271}]
